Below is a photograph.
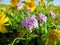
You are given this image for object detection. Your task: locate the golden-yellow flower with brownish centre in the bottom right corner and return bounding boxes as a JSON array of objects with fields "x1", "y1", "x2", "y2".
[{"x1": 45, "y1": 29, "x2": 60, "y2": 45}]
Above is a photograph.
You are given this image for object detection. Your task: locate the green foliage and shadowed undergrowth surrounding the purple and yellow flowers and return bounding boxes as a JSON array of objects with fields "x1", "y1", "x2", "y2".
[{"x1": 0, "y1": 0, "x2": 60, "y2": 45}]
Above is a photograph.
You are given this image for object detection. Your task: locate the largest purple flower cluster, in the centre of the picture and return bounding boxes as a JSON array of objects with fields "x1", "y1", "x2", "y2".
[{"x1": 22, "y1": 15, "x2": 38, "y2": 32}]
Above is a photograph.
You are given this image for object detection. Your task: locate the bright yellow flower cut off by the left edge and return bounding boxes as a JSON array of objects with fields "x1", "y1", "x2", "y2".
[{"x1": 0, "y1": 13, "x2": 9, "y2": 33}]
